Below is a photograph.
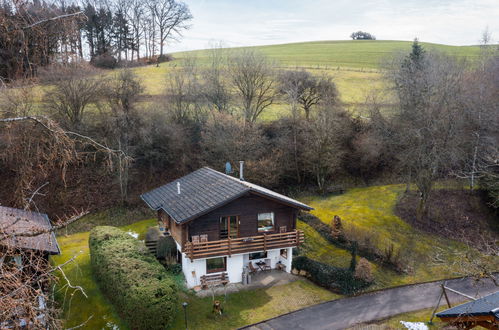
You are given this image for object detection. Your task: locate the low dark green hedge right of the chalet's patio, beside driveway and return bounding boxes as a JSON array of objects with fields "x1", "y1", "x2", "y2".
[{"x1": 293, "y1": 256, "x2": 370, "y2": 294}]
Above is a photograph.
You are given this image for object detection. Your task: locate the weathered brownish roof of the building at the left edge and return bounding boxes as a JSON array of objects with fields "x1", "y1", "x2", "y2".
[{"x1": 0, "y1": 206, "x2": 60, "y2": 254}]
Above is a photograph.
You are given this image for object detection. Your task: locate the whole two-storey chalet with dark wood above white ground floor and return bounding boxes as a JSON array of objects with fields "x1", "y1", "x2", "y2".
[{"x1": 141, "y1": 165, "x2": 312, "y2": 288}]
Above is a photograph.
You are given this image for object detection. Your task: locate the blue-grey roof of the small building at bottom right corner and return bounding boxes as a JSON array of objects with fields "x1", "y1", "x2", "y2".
[{"x1": 437, "y1": 291, "x2": 499, "y2": 319}]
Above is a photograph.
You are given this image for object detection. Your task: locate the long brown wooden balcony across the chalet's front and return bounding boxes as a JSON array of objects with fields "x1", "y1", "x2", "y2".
[{"x1": 182, "y1": 230, "x2": 305, "y2": 261}]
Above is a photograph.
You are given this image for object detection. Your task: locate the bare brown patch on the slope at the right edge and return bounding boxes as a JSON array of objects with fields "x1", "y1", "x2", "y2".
[{"x1": 395, "y1": 190, "x2": 499, "y2": 253}]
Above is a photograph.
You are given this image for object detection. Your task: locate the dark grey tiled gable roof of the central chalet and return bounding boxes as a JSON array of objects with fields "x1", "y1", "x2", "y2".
[{"x1": 140, "y1": 167, "x2": 312, "y2": 223}]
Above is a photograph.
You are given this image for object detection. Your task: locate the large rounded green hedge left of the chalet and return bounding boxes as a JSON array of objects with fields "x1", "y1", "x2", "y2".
[{"x1": 89, "y1": 226, "x2": 178, "y2": 329}]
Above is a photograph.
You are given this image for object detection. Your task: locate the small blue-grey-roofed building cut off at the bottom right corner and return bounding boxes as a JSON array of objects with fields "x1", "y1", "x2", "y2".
[{"x1": 436, "y1": 291, "x2": 499, "y2": 329}]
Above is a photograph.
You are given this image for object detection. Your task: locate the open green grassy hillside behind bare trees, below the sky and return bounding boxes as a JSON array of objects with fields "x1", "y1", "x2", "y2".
[{"x1": 135, "y1": 40, "x2": 480, "y2": 120}]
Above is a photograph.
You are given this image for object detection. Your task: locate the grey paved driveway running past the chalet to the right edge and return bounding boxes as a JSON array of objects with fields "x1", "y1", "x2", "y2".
[{"x1": 244, "y1": 275, "x2": 499, "y2": 330}]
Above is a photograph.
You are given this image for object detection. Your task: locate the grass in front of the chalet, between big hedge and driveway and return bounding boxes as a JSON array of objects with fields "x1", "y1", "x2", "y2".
[{"x1": 172, "y1": 280, "x2": 340, "y2": 329}]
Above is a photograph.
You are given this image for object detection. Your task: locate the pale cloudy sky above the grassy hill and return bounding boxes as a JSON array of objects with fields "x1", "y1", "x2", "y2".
[{"x1": 169, "y1": 0, "x2": 499, "y2": 52}]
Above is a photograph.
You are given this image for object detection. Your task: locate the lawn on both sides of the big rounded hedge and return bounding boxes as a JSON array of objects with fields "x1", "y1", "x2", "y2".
[{"x1": 52, "y1": 214, "x2": 339, "y2": 329}]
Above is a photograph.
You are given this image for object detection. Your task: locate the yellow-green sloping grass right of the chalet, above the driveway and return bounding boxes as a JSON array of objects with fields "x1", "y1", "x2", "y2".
[{"x1": 298, "y1": 185, "x2": 499, "y2": 289}]
